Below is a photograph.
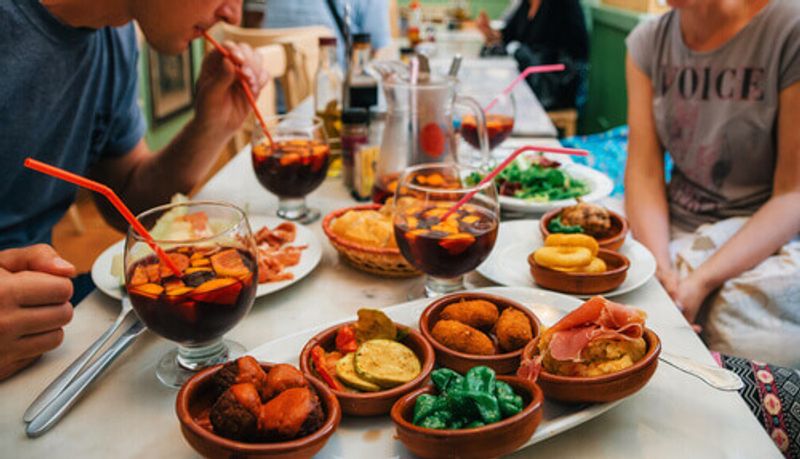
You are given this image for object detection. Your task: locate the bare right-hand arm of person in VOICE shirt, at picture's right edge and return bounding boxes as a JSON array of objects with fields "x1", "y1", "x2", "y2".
[{"x1": 675, "y1": 83, "x2": 800, "y2": 321}]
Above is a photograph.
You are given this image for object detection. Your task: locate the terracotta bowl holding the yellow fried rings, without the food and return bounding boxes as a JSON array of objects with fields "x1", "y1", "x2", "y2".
[{"x1": 528, "y1": 249, "x2": 631, "y2": 295}]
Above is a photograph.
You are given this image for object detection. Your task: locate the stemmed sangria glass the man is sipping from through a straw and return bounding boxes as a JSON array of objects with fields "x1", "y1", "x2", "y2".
[{"x1": 252, "y1": 115, "x2": 330, "y2": 224}]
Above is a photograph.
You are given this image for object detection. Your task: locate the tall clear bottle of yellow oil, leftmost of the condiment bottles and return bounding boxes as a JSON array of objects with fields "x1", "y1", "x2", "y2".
[{"x1": 314, "y1": 37, "x2": 344, "y2": 155}]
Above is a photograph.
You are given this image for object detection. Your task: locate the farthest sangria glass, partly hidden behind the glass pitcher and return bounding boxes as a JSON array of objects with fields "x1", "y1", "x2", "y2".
[{"x1": 460, "y1": 91, "x2": 517, "y2": 151}]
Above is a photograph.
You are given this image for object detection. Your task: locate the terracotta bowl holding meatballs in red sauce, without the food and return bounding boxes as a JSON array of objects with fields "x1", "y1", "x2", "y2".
[{"x1": 175, "y1": 362, "x2": 342, "y2": 459}]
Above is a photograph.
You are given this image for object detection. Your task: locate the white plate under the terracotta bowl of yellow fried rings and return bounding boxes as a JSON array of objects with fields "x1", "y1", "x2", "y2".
[{"x1": 477, "y1": 220, "x2": 656, "y2": 298}]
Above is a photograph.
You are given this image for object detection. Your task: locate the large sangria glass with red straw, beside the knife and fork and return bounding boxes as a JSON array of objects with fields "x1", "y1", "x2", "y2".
[{"x1": 124, "y1": 201, "x2": 258, "y2": 387}]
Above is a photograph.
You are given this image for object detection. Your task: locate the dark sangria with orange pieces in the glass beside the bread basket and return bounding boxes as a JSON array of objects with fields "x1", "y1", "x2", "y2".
[{"x1": 394, "y1": 201, "x2": 497, "y2": 278}]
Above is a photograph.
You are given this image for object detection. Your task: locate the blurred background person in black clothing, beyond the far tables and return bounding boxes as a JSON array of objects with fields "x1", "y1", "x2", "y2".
[{"x1": 477, "y1": 0, "x2": 589, "y2": 110}]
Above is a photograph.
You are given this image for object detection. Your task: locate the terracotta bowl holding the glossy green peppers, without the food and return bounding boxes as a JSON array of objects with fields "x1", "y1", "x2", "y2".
[{"x1": 392, "y1": 376, "x2": 543, "y2": 458}]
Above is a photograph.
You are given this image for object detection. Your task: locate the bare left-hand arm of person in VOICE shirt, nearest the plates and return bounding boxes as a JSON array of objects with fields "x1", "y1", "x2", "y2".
[{"x1": 625, "y1": 56, "x2": 677, "y2": 294}]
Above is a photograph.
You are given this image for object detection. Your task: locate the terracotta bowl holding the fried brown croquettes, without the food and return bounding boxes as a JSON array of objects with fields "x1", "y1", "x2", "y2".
[{"x1": 419, "y1": 292, "x2": 541, "y2": 375}]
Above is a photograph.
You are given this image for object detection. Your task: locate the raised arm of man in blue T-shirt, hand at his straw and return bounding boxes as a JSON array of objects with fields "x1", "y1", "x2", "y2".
[{"x1": 90, "y1": 43, "x2": 268, "y2": 229}]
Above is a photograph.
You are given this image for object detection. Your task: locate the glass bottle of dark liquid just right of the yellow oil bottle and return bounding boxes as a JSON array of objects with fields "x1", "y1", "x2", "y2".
[{"x1": 344, "y1": 33, "x2": 378, "y2": 110}]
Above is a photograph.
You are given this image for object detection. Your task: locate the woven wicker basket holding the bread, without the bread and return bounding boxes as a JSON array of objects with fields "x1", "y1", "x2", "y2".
[{"x1": 322, "y1": 204, "x2": 422, "y2": 277}]
